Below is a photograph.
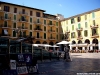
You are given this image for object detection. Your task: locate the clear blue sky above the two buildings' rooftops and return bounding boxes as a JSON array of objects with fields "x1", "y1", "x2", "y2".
[{"x1": 0, "y1": 0, "x2": 100, "y2": 18}]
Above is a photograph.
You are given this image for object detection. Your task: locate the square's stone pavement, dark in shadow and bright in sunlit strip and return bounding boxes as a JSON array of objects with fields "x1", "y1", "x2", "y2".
[{"x1": 34, "y1": 53, "x2": 100, "y2": 75}]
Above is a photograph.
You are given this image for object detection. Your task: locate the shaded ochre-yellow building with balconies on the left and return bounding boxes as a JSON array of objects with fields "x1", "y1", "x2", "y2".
[{"x1": 0, "y1": 2, "x2": 60, "y2": 44}]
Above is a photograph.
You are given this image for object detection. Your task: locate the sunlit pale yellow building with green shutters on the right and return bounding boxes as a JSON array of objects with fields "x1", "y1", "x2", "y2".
[{"x1": 61, "y1": 8, "x2": 100, "y2": 50}]
